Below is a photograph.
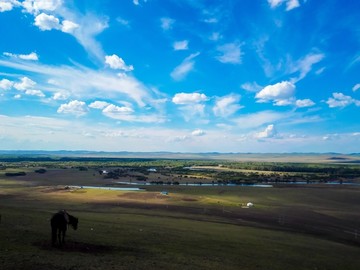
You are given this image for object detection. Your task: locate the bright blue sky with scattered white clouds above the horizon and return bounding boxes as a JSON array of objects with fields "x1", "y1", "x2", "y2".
[{"x1": 0, "y1": 0, "x2": 360, "y2": 153}]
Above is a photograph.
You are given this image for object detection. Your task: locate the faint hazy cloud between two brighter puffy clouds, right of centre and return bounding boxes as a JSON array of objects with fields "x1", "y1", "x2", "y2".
[{"x1": 213, "y1": 94, "x2": 243, "y2": 117}]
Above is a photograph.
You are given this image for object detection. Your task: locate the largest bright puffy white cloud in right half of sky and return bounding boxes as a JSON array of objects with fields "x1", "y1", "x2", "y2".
[{"x1": 255, "y1": 81, "x2": 295, "y2": 106}]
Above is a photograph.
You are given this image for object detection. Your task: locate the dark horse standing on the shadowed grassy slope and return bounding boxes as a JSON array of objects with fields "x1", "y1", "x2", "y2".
[{"x1": 51, "y1": 210, "x2": 79, "y2": 246}]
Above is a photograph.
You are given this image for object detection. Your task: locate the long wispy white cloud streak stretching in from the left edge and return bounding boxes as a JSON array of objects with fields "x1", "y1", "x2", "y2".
[{"x1": 0, "y1": 59, "x2": 152, "y2": 107}]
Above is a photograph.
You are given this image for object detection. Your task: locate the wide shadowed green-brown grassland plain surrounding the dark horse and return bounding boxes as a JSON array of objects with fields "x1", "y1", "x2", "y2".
[{"x1": 0, "y1": 156, "x2": 360, "y2": 270}]
